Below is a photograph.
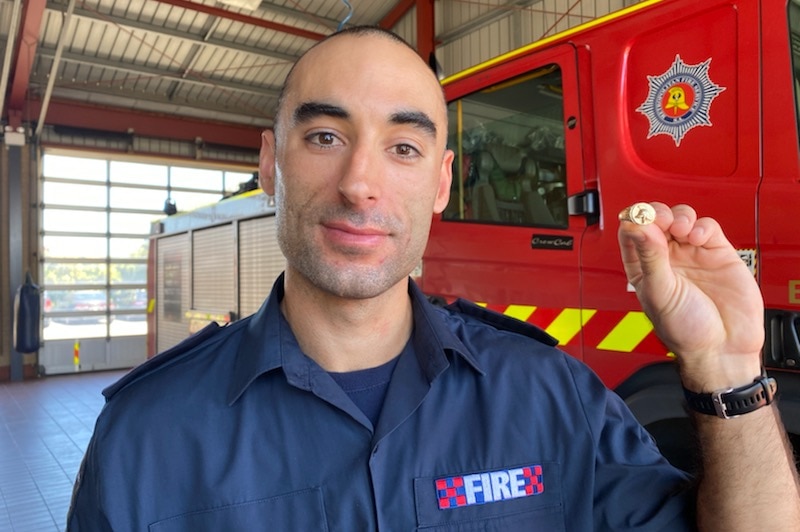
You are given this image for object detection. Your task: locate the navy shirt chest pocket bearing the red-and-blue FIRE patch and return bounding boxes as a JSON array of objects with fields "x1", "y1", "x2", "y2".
[{"x1": 414, "y1": 462, "x2": 565, "y2": 532}]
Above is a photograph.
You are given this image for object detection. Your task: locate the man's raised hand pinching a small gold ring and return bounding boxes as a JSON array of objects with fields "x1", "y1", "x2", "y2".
[{"x1": 618, "y1": 202, "x2": 764, "y2": 391}]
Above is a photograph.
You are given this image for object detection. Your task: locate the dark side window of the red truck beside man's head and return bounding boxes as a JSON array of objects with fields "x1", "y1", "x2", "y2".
[{"x1": 442, "y1": 65, "x2": 567, "y2": 227}]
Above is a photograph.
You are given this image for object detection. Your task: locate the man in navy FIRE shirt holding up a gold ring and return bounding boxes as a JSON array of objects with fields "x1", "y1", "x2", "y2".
[{"x1": 68, "y1": 28, "x2": 800, "y2": 532}]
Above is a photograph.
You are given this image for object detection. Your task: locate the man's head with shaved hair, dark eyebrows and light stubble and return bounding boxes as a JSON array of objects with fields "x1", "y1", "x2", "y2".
[{"x1": 261, "y1": 35, "x2": 453, "y2": 299}]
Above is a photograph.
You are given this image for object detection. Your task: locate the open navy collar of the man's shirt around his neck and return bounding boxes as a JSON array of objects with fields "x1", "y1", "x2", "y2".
[{"x1": 228, "y1": 274, "x2": 483, "y2": 404}]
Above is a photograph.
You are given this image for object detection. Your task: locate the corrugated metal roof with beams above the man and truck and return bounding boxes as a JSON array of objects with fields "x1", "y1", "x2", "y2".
[{"x1": 0, "y1": 0, "x2": 625, "y2": 152}]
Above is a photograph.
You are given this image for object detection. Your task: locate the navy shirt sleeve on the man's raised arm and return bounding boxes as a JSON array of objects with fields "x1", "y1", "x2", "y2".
[{"x1": 567, "y1": 357, "x2": 697, "y2": 532}]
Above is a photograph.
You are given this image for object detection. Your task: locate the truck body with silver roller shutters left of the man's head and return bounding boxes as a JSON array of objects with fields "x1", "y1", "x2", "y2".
[{"x1": 147, "y1": 190, "x2": 286, "y2": 357}]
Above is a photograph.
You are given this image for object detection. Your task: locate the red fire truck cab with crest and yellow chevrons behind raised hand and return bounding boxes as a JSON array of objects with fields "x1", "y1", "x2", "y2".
[{"x1": 418, "y1": 0, "x2": 800, "y2": 468}]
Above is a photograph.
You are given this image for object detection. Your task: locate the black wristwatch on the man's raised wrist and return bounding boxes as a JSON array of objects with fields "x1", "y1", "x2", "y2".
[{"x1": 683, "y1": 375, "x2": 778, "y2": 419}]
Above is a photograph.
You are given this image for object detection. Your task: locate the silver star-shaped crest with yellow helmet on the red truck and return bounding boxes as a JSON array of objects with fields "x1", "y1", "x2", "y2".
[{"x1": 636, "y1": 55, "x2": 725, "y2": 146}]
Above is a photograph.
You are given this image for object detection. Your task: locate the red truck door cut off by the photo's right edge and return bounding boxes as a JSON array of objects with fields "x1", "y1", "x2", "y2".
[{"x1": 757, "y1": 2, "x2": 800, "y2": 372}]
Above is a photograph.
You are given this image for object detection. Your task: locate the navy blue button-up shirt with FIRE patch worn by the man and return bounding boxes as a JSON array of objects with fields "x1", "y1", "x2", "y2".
[{"x1": 68, "y1": 278, "x2": 694, "y2": 532}]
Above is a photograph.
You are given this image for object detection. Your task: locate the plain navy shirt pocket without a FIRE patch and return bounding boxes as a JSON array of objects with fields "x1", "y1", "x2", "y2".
[{"x1": 148, "y1": 488, "x2": 328, "y2": 532}]
